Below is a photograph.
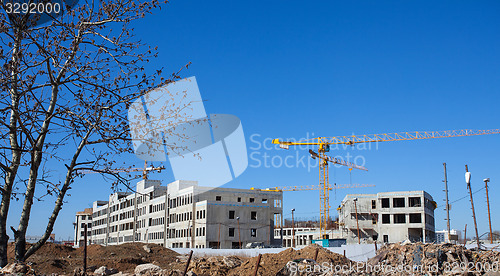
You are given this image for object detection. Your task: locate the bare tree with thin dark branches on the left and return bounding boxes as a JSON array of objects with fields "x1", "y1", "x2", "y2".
[{"x1": 0, "y1": 0, "x2": 190, "y2": 266}]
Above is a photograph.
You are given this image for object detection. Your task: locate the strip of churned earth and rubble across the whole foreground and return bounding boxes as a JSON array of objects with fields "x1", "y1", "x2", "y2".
[{"x1": 2, "y1": 243, "x2": 500, "y2": 276}]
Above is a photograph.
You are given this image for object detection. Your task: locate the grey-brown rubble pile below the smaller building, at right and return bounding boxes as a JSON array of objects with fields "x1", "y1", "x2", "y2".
[{"x1": 364, "y1": 242, "x2": 500, "y2": 275}]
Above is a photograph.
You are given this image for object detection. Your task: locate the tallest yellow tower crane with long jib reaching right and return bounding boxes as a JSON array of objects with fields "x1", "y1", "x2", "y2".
[{"x1": 272, "y1": 129, "x2": 500, "y2": 237}]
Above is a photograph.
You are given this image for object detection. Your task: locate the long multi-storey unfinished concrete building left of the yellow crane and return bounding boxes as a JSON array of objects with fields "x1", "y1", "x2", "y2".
[{"x1": 76, "y1": 180, "x2": 283, "y2": 248}]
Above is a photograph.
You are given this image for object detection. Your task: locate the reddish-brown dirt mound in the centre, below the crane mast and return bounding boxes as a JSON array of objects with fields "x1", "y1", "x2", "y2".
[{"x1": 228, "y1": 244, "x2": 352, "y2": 275}]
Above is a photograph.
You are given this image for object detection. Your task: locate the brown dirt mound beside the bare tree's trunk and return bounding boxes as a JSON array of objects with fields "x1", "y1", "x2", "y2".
[{"x1": 9, "y1": 243, "x2": 179, "y2": 274}]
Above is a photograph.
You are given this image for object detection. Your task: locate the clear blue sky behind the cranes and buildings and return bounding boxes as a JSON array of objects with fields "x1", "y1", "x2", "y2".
[{"x1": 9, "y1": 0, "x2": 500, "y2": 238}]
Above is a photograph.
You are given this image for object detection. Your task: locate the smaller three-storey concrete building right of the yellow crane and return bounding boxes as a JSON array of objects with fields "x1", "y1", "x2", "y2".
[{"x1": 338, "y1": 191, "x2": 436, "y2": 244}]
